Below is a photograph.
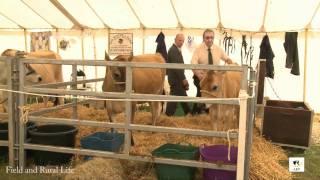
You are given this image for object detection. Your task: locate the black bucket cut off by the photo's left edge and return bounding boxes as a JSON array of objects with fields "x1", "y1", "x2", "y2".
[{"x1": 0, "y1": 122, "x2": 36, "y2": 158}]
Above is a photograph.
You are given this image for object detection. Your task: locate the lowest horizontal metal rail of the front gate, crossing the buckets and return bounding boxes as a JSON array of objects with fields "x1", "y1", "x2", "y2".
[{"x1": 24, "y1": 143, "x2": 236, "y2": 171}]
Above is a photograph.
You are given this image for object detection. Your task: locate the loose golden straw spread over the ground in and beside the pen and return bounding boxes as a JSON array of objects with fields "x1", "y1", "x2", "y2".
[{"x1": 26, "y1": 106, "x2": 293, "y2": 180}]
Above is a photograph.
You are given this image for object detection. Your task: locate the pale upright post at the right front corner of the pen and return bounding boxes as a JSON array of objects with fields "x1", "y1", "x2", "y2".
[{"x1": 237, "y1": 90, "x2": 248, "y2": 180}]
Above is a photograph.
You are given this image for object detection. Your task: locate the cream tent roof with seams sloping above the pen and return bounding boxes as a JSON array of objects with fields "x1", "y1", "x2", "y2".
[{"x1": 0, "y1": 0, "x2": 320, "y2": 32}]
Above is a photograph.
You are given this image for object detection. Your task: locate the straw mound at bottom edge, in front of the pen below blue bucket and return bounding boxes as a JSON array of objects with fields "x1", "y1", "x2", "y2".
[{"x1": 65, "y1": 158, "x2": 126, "y2": 180}]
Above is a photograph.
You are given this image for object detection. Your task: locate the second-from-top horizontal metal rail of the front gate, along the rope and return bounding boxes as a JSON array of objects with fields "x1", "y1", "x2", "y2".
[{"x1": 24, "y1": 87, "x2": 239, "y2": 105}]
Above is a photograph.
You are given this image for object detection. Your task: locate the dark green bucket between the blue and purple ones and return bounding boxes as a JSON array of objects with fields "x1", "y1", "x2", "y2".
[{"x1": 152, "y1": 144, "x2": 199, "y2": 180}]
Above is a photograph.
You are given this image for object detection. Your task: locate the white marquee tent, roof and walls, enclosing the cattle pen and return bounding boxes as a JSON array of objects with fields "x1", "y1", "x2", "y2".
[{"x1": 0, "y1": 0, "x2": 320, "y2": 112}]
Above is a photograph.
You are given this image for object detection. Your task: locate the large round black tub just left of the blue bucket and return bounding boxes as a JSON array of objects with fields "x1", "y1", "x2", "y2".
[{"x1": 29, "y1": 124, "x2": 78, "y2": 165}]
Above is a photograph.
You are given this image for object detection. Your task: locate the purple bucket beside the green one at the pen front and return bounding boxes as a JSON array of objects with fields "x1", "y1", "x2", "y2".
[{"x1": 200, "y1": 145, "x2": 238, "y2": 180}]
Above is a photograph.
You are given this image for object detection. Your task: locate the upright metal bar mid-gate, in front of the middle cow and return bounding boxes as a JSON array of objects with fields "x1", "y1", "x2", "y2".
[{"x1": 124, "y1": 66, "x2": 133, "y2": 155}]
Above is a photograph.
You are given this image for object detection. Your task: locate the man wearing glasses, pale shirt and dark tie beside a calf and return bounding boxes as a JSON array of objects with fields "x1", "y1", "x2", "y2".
[{"x1": 191, "y1": 29, "x2": 233, "y2": 114}]
